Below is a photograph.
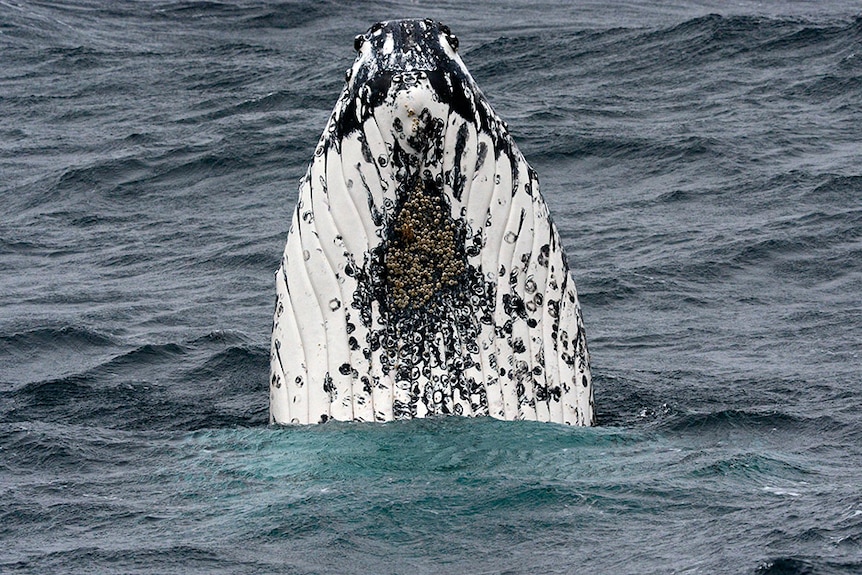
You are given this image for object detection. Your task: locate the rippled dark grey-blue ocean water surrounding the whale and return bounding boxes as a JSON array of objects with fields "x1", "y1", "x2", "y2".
[{"x1": 0, "y1": 0, "x2": 862, "y2": 575}]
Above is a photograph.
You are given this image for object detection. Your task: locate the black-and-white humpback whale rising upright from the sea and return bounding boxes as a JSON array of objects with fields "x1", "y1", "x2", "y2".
[{"x1": 270, "y1": 19, "x2": 594, "y2": 425}]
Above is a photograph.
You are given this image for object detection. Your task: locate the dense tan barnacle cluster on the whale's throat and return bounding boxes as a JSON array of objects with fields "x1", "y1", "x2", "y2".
[{"x1": 384, "y1": 179, "x2": 466, "y2": 309}]
